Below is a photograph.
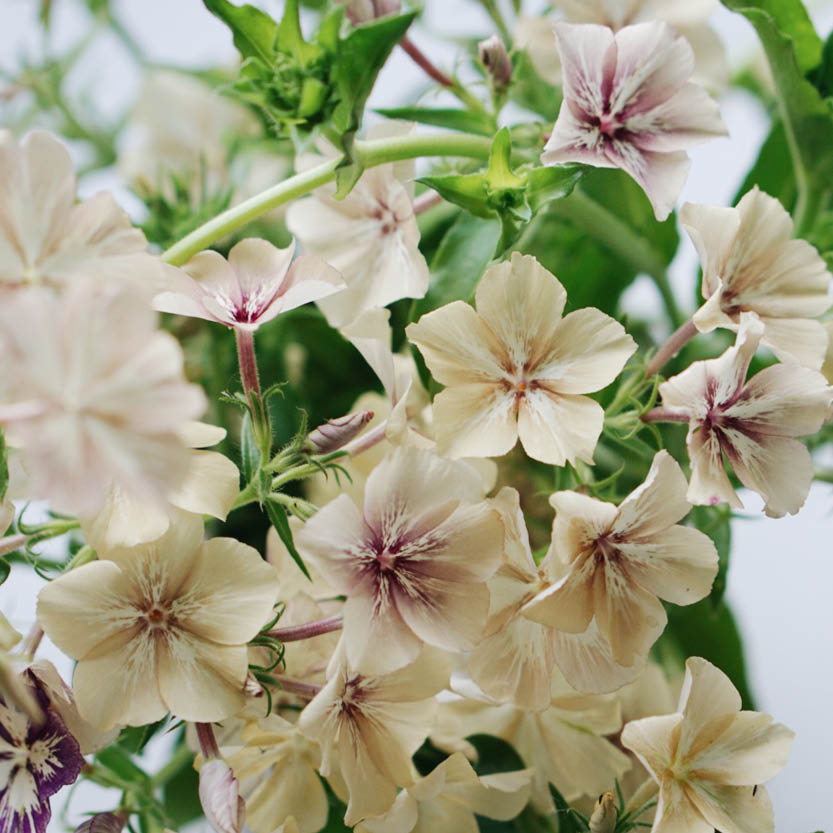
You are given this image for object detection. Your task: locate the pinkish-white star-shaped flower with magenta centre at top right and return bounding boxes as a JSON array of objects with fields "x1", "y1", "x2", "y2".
[{"x1": 541, "y1": 22, "x2": 726, "y2": 220}]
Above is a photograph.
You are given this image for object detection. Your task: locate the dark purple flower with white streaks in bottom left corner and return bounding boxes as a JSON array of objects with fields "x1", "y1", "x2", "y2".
[{"x1": 0, "y1": 676, "x2": 84, "y2": 833}]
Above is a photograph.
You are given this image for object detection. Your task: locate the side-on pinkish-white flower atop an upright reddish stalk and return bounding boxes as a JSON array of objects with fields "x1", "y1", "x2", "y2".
[{"x1": 153, "y1": 237, "x2": 344, "y2": 332}]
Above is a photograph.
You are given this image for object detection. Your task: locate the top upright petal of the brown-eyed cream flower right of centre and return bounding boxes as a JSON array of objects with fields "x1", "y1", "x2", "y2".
[{"x1": 475, "y1": 252, "x2": 564, "y2": 368}]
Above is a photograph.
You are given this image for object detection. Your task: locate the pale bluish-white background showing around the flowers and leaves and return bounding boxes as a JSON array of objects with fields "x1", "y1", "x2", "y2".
[{"x1": 0, "y1": 0, "x2": 833, "y2": 833}]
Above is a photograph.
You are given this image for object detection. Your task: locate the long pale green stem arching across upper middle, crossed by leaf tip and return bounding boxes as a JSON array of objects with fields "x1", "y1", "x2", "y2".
[{"x1": 162, "y1": 133, "x2": 491, "y2": 266}]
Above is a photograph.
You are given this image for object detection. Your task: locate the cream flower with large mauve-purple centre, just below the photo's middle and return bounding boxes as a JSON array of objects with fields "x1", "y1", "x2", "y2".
[{"x1": 296, "y1": 448, "x2": 503, "y2": 674}]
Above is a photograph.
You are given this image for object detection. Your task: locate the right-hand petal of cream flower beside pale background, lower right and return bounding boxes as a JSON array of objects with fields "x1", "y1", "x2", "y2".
[{"x1": 618, "y1": 526, "x2": 718, "y2": 605}]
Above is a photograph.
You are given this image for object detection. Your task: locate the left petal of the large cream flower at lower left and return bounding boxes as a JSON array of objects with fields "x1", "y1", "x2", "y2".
[{"x1": 37, "y1": 561, "x2": 139, "y2": 659}]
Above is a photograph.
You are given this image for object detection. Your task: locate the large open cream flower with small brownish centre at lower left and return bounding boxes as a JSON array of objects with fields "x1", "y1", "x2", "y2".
[{"x1": 38, "y1": 513, "x2": 278, "y2": 728}]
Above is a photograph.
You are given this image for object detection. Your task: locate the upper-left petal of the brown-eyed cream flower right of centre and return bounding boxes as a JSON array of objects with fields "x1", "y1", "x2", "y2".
[{"x1": 405, "y1": 301, "x2": 505, "y2": 385}]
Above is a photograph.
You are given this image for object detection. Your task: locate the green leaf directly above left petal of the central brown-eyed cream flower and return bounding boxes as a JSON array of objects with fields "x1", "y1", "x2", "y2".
[{"x1": 413, "y1": 214, "x2": 500, "y2": 318}]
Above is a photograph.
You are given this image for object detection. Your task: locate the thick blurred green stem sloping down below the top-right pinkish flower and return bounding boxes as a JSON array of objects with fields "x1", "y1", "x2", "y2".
[{"x1": 550, "y1": 190, "x2": 685, "y2": 329}]
